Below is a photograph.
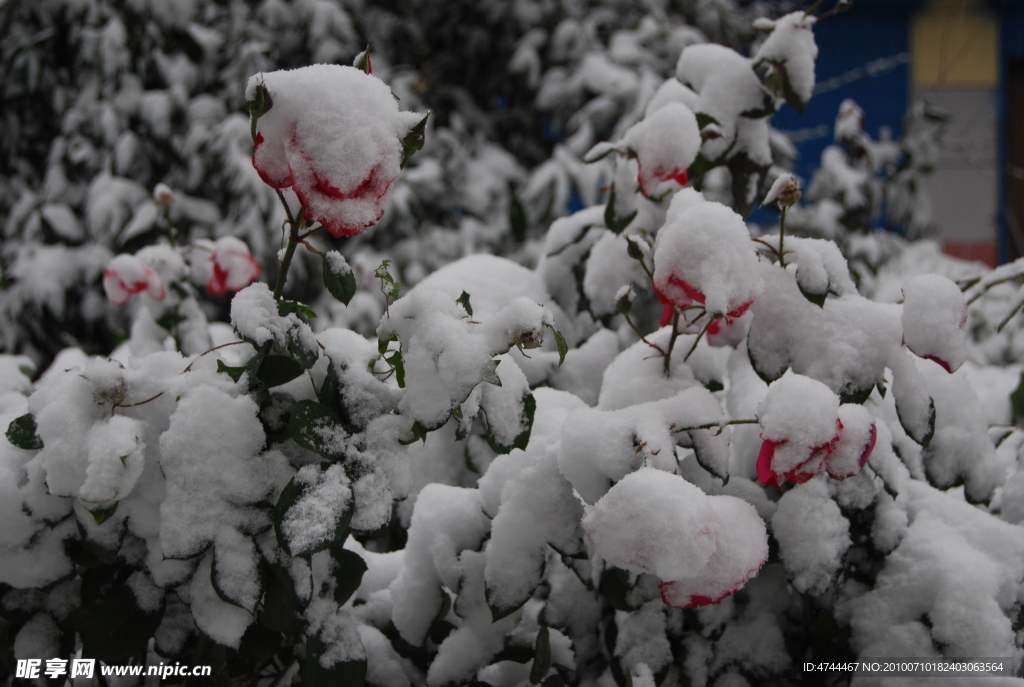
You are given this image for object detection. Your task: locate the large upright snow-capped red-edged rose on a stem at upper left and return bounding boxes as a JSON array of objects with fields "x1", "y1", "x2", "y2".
[{"x1": 246, "y1": 65, "x2": 423, "y2": 237}]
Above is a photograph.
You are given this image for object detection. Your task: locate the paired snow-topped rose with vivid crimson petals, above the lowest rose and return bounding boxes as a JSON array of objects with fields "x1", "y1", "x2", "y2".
[{"x1": 757, "y1": 375, "x2": 878, "y2": 487}]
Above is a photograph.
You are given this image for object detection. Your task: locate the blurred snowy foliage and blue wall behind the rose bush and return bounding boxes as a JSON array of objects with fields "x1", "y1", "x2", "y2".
[{"x1": 0, "y1": 0, "x2": 1024, "y2": 364}]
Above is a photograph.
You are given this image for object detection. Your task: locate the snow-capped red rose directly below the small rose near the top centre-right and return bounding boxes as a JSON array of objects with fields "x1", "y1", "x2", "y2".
[{"x1": 654, "y1": 188, "x2": 761, "y2": 318}]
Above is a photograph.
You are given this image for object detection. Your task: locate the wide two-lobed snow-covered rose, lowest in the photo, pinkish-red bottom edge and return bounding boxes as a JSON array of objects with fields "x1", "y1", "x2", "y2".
[{"x1": 583, "y1": 468, "x2": 768, "y2": 608}]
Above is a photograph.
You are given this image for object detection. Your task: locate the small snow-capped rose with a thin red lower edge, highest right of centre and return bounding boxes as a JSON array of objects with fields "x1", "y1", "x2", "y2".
[{"x1": 622, "y1": 102, "x2": 700, "y2": 196}]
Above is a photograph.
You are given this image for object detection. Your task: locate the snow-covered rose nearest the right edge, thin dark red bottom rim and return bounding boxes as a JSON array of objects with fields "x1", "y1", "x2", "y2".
[{"x1": 900, "y1": 274, "x2": 967, "y2": 373}]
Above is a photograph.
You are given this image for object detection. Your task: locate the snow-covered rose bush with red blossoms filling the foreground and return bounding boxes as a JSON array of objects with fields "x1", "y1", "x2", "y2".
[{"x1": 0, "y1": 3, "x2": 1024, "y2": 687}]
